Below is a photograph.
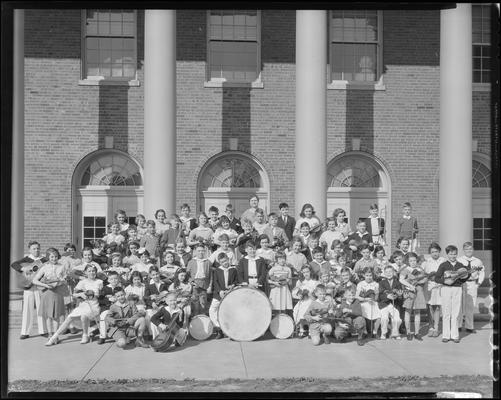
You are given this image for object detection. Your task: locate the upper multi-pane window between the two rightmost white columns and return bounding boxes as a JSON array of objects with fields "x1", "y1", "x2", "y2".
[{"x1": 329, "y1": 10, "x2": 382, "y2": 82}]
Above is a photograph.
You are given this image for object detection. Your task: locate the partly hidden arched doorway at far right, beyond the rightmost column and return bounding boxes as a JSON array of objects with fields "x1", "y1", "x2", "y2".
[{"x1": 472, "y1": 153, "x2": 493, "y2": 286}]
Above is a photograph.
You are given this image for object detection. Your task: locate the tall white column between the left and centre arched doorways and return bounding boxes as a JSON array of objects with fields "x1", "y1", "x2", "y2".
[{"x1": 143, "y1": 10, "x2": 176, "y2": 219}]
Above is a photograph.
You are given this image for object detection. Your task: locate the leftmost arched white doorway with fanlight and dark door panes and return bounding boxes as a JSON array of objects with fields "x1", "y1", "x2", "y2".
[{"x1": 73, "y1": 150, "x2": 143, "y2": 248}]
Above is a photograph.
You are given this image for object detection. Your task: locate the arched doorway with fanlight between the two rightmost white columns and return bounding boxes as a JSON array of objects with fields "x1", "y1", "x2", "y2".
[{"x1": 327, "y1": 152, "x2": 391, "y2": 244}]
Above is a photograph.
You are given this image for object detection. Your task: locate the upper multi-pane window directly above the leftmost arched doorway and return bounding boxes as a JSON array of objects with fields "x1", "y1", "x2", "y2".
[{"x1": 83, "y1": 10, "x2": 136, "y2": 80}]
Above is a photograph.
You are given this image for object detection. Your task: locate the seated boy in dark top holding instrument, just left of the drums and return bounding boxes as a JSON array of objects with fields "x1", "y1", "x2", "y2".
[{"x1": 151, "y1": 292, "x2": 188, "y2": 346}]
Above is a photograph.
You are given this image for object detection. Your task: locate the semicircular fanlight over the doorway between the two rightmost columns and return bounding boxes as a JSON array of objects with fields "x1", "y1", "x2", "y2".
[{"x1": 327, "y1": 157, "x2": 381, "y2": 187}]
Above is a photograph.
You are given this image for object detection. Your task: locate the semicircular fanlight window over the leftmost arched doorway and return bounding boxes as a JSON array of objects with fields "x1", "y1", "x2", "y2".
[{"x1": 81, "y1": 154, "x2": 143, "y2": 186}]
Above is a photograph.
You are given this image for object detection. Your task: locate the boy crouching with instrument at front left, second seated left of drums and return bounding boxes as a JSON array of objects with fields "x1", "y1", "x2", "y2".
[{"x1": 106, "y1": 290, "x2": 146, "y2": 349}]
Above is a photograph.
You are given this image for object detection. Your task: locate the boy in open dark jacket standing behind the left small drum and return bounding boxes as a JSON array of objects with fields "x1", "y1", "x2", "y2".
[{"x1": 186, "y1": 243, "x2": 212, "y2": 315}]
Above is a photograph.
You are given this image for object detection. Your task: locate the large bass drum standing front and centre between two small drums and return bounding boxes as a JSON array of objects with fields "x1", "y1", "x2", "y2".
[{"x1": 218, "y1": 286, "x2": 271, "y2": 342}]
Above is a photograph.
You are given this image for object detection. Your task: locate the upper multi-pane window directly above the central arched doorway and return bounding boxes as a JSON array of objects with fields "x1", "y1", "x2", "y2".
[{"x1": 208, "y1": 10, "x2": 260, "y2": 83}]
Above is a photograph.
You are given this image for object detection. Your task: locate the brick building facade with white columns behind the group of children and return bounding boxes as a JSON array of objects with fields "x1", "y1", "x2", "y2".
[{"x1": 9, "y1": 4, "x2": 492, "y2": 282}]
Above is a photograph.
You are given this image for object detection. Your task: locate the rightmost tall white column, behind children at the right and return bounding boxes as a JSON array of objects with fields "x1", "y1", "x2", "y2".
[{"x1": 439, "y1": 3, "x2": 473, "y2": 250}]
